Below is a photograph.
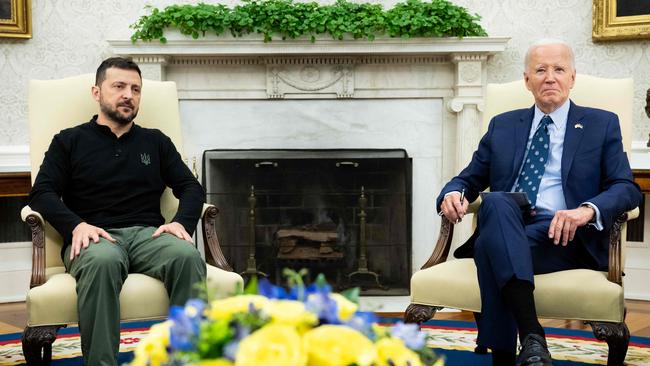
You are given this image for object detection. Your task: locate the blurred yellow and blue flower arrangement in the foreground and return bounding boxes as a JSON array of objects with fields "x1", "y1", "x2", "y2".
[{"x1": 131, "y1": 270, "x2": 444, "y2": 366}]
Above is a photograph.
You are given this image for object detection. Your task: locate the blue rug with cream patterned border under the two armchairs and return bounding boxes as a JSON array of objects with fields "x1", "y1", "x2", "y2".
[{"x1": 0, "y1": 318, "x2": 650, "y2": 366}]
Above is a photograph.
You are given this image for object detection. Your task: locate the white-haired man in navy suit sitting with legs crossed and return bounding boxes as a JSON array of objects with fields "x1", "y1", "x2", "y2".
[{"x1": 437, "y1": 40, "x2": 641, "y2": 366}]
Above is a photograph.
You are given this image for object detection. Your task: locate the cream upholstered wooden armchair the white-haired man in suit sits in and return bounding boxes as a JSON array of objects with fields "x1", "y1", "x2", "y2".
[{"x1": 405, "y1": 75, "x2": 638, "y2": 365}]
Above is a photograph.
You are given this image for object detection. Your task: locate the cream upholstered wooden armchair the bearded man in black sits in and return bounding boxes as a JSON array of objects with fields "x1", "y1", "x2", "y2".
[{"x1": 21, "y1": 74, "x2": 243, "y2": 365}]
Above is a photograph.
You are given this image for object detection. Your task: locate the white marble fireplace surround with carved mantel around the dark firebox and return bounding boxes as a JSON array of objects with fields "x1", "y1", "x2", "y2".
[{"x1": 109, "y1": 34, "x2": 508, "y2": 298}]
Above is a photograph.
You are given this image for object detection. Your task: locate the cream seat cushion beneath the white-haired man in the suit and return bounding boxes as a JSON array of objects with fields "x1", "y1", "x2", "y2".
[{"x1": 411, "y1": 259, "x2": 624, "y2": 322}]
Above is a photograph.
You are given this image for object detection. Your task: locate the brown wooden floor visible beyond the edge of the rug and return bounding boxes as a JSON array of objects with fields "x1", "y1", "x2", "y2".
[{"x1": 0, "y1": 300, "x2": 650, "y2": 337}]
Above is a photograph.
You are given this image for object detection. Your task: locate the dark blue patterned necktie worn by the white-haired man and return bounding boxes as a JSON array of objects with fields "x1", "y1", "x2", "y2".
[{"x1": 515, "y1": 115, "x2": 553, "y2": 208}]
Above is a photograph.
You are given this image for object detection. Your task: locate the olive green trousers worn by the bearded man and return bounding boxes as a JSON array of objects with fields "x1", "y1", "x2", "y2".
[{"x1": 64, "y1": 226, "x2": 206, "y2": 366}]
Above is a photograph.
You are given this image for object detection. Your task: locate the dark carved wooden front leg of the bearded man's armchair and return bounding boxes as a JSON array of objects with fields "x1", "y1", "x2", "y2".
[{"x1": 21, "y1": 325, "x2": 65, "y2": 366}]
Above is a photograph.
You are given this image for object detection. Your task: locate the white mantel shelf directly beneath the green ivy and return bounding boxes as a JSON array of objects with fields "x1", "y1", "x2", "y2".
[{"x1": 108, "y1": 33, "x2": 510, "y2": 57}]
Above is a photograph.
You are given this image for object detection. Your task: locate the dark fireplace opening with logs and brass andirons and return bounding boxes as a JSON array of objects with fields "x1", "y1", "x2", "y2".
[{"x1": 202, "y1": 149, "x2": 412, "y2": 295}]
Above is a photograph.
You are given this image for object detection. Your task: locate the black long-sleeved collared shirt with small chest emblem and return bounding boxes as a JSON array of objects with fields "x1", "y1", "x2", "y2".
[{"x1": 29, "y1": 116, "x2": 205, "y2": 249}]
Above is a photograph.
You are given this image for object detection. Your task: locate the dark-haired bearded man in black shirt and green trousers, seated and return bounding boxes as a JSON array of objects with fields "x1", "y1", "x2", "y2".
[{"x1": 29, "y1": 57, "x2": 206, "y2": 365}]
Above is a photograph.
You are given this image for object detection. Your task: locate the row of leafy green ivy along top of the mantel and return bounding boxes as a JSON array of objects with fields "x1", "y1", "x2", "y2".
[{"x1": 131, "y1": 0, "x2": 487, "y2": 43}]
